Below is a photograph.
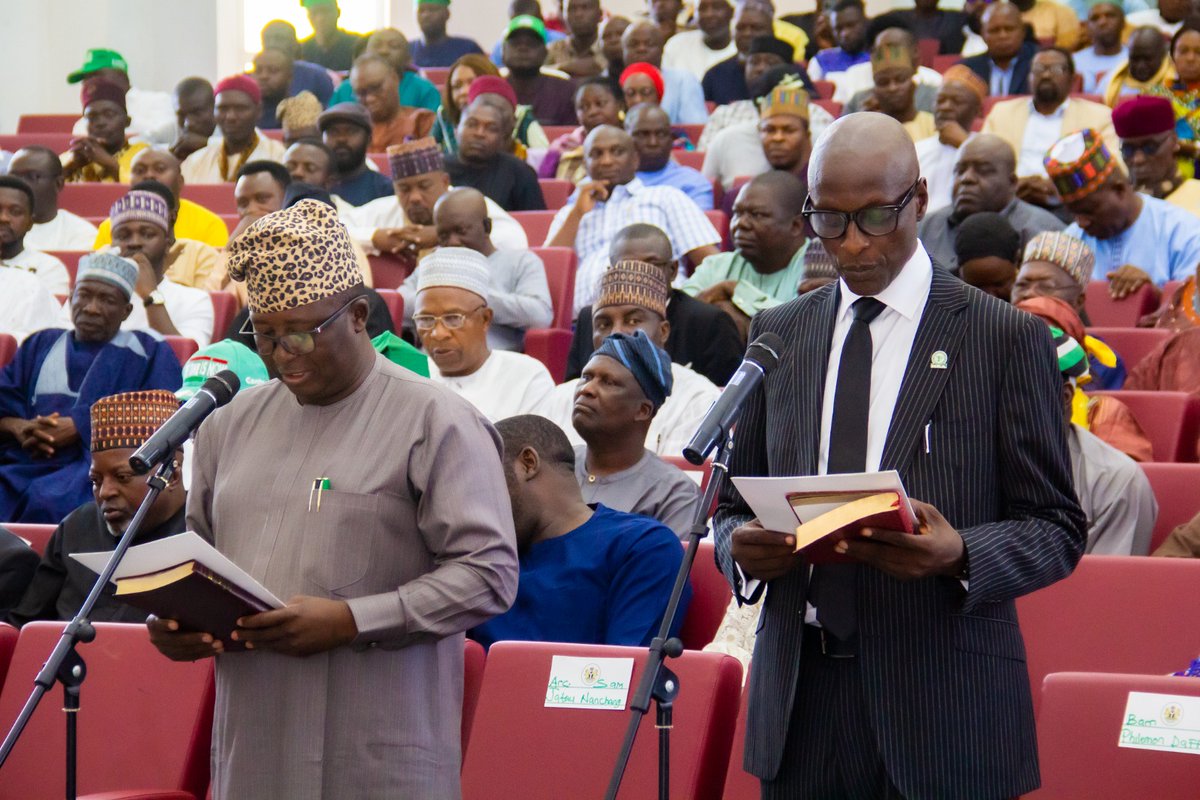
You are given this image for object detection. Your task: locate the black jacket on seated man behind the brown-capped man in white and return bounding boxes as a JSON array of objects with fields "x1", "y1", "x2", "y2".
[{"x1": 566, "y1": 289, "x2": 745, "y2": 386}]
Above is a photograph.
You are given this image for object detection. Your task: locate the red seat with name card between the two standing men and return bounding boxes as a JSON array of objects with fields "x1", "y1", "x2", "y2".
[{"x1": 462, "y1": 642, "x2": 742, "y2": 800}]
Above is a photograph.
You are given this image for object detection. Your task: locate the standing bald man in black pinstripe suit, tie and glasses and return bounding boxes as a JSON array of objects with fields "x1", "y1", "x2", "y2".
[{"x1": 715, "y1": 114, "x2": 1086, "y2": 800}]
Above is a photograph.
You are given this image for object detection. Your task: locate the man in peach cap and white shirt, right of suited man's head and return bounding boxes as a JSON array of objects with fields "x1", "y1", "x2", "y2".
[{"x1": 917, "y1": 64, "x2": 988, "y2": 213}]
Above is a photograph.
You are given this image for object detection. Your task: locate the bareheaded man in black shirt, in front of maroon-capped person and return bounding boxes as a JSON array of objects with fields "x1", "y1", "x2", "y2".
[{"x1": 445, "y1": 91, "x2": 546, "y2": 211}]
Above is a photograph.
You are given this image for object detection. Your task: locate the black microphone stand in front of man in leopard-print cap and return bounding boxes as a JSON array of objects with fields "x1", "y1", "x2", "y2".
[{"x1": 0, "y1": 453, "x2": 175, "y2": 800}]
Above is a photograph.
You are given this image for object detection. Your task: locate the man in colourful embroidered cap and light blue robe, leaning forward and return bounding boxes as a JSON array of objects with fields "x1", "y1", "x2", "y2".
[{"x1": 1045, "y1": 128, "x2": 1200, "y2": 300}]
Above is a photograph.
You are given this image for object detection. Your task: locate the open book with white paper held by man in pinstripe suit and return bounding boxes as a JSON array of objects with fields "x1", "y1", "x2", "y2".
[{"x1": 733, "y1": 470, "x2": 916, "y2": 564}]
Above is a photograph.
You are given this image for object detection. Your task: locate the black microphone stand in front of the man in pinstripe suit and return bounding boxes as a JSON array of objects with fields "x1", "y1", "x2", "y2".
[{"x1": 605, "y1": 433, "x2": 733, "y2": 800}]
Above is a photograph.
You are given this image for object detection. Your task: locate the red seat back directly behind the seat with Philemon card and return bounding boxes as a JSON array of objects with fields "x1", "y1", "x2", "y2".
[{"x1": 1016, "y1": 555, "x2": 1200, "y2": 709}]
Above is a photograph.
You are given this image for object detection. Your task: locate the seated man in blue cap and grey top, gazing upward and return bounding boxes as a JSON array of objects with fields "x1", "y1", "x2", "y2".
[{"x1": 570, "y1": 328, "x2": 700, "y2": 537}]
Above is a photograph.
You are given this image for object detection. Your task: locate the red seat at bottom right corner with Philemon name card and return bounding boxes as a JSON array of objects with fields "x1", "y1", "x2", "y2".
[{"x1": 1025, "y1": 664, "x2": 1200, "y2": 800}]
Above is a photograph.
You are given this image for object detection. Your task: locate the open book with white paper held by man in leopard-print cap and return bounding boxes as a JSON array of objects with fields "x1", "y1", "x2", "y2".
[{"x1": 71, "y1": 531, "x2": 283, "y2": 650}]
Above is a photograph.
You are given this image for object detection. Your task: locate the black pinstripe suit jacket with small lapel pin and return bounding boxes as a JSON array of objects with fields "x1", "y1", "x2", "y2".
[{"x1": 715, "y1": 269, "x2": 1086, "y2": 799}]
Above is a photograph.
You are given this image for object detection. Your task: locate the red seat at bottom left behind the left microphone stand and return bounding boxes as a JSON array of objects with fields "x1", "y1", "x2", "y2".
[{"x1": 0, "y1": 622, "x2": 212, "y2": 800}]
